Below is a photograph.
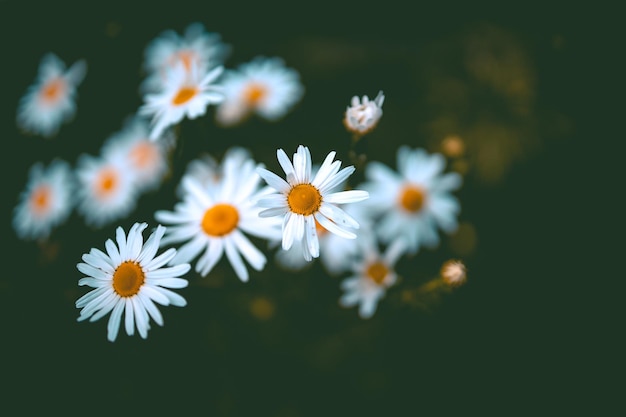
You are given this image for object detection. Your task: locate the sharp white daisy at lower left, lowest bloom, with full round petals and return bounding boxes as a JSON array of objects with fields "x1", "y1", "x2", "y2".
[{"x1": 76, "y1": 223, "x2": 191, "y2": 342}]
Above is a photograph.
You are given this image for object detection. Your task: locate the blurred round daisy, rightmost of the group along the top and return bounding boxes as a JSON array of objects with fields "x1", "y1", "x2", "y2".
[{"x1": 215, "y1": 57, "x2": 304, "y2": 126}]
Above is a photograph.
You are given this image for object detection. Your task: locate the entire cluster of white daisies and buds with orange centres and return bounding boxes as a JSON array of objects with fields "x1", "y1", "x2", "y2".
[{"x1": 13, "y1": 23, "x2": 464, "y2": 341}]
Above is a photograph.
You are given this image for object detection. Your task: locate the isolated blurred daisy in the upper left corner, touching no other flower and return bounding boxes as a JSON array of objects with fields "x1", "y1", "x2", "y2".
[{"x1": 17, "y1": 53, "x2": 87, "y2": 138}]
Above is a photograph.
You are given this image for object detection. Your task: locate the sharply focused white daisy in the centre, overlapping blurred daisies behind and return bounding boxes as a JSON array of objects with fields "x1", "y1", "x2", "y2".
[{"x1": 257, "y1": 145, "x2": 368, "y2": 261}]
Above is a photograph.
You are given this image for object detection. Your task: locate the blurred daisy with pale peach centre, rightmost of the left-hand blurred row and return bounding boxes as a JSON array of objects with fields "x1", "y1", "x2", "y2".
[{"x1": 101, "y1": 116, "x2": 175, "y2": 192}]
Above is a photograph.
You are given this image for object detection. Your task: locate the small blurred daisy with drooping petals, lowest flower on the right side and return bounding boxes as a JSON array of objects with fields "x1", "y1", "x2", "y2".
[{"x1": 339, "y1": 234, "x2": 405, "y2": 319}]
